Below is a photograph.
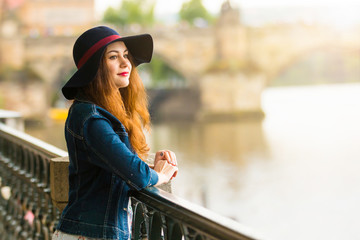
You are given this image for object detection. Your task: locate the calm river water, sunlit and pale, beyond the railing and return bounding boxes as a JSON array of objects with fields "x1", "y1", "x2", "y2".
[{"x1": 26, "y1": 84, "x2": 360, "y2": 240}]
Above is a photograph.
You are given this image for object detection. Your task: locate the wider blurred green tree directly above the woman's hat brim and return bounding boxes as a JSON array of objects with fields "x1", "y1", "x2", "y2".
[{"x1": 103, "y1": 0, "x2": 156, "y2": 27}]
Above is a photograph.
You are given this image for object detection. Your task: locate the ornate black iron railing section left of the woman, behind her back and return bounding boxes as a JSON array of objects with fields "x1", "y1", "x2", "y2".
[{"x1": 0, "y1": 123, "x2": 67, "y2": 240}]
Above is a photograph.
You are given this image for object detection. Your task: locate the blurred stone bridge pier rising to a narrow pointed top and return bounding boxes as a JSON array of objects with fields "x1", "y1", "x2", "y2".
[{"x1": 199, "y1": 0, "x2": 265, "y2": 119}]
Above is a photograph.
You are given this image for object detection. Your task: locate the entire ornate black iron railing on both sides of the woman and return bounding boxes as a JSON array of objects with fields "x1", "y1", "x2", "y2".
[{"x1": 0, "y1": 123, "x2": 259, "y2": 240}]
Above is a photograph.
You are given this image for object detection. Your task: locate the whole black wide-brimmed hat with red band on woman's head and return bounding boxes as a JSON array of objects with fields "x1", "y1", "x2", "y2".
[{"x1": 62, "y1": 26, "x2": 153, "y2": 100}]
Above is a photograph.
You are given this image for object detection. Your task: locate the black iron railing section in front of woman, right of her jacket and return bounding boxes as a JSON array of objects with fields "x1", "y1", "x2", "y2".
[{"x1": 131, "y1": 187, "x2": 259, "y2": 240}]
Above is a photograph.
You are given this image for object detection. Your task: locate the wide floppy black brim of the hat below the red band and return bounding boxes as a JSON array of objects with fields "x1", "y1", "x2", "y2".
[{"x1": 62, "y1": 34, "x2": 153, "y2": 100}]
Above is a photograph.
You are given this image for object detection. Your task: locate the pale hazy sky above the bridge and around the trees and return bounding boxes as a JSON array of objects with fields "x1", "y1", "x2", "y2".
[{"x1": 95, "y1": 0, "x2": 360, "y2": 29}]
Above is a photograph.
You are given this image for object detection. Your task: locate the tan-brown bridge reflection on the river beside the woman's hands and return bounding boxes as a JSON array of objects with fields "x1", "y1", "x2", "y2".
[{"x1": 148, "y1": 121, "x2": 267, "y2": 166}]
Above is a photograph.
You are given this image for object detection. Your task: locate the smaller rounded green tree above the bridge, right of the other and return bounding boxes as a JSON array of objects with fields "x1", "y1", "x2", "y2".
[{"x1": 179, "y1": 0, "x2": 214, "y2": 26}]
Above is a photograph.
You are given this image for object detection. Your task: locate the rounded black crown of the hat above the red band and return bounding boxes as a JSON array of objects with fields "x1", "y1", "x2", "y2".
[{"x1": 73, "y1": 26, "x2": 120, "y2": 66}]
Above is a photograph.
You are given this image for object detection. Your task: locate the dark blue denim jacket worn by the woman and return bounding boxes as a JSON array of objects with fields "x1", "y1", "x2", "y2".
[{"x1": 57, "y1": 100, "x2": 158, "y2": 240}]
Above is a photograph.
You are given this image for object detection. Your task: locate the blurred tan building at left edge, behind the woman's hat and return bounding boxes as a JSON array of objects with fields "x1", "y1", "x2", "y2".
[{"x1": 0, "y1": 0, "x2": 96, "y2": 119}]
